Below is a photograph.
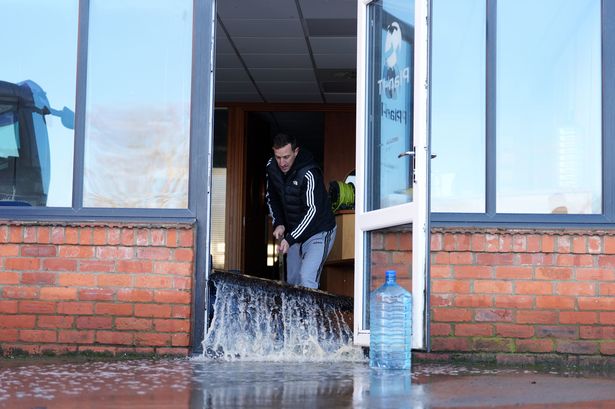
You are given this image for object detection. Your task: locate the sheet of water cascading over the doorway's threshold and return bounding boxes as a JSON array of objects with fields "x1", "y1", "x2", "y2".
[{"x1": 203, "y1": 273, "x2": 365, "y2": 361}]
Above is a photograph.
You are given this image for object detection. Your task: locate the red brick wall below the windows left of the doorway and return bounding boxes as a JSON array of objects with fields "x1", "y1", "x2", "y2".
[{"x1": 0, "y1": 222, "x2": 194, "y2": 355}]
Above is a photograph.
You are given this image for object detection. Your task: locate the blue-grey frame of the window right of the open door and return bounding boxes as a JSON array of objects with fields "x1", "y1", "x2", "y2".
[{"x1": 430, "y1": 0, "x2": 615, "y2": 228}]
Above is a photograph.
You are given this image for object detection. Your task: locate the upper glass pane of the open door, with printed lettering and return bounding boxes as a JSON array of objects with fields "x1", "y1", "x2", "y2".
[{"x1": 366, "y1": 0, "x2": 414, "y2": 210}]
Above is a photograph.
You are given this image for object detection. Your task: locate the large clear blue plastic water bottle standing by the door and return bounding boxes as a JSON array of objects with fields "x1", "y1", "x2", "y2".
[{"x1": 369, "y1": 270, "x2": 412, "y2": 369}]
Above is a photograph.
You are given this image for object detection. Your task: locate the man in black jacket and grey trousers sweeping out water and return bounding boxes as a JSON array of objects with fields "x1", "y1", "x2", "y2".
[{"x1": 266, "y1": 133, "x2": 336, "y2": 288}]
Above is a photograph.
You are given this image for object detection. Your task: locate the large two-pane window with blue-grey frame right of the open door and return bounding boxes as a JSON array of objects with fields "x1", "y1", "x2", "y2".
[{"x1": 431, "y1": 0, "x2": 615, "y2": 223}]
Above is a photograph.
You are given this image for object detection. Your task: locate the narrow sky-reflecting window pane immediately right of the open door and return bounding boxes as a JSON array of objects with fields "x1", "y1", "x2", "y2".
[{"x1": 431, "y1": 0, "x2": 486, "y2": 213}]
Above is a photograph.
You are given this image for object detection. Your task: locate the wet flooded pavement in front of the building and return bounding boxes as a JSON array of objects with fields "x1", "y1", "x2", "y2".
[{"x1": 0, "y1": 358, "x2": 615, "y2": 409}]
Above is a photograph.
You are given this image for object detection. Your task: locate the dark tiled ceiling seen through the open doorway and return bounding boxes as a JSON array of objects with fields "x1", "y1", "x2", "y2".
[{"x1": 215, "y1": 0, "x2": 357, "y2": 103}]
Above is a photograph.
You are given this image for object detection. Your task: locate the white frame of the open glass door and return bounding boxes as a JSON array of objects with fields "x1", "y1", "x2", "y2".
[{"x1": 354, "y1": 0, "x2": 430, "y2": 349}]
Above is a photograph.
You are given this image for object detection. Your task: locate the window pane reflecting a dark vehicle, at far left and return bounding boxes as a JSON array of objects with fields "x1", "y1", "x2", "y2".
[{"x1": 0, "y1": 0, "x2": 78, "y2": 207}]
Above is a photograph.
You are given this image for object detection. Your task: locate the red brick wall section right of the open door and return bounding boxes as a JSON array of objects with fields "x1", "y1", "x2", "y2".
[{"x1": 430, "y1": 229, "x2": 615, "y2": 356}]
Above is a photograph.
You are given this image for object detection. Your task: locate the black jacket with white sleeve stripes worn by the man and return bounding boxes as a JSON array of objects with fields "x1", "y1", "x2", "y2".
[{"x1": 266, "y1": 149, "x2": 335, "y2": 245}]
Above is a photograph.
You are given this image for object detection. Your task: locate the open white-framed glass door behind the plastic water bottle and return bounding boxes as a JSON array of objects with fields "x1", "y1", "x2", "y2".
[{"x1": 354, "y1": 0, "x2": 429, "y2": 349}]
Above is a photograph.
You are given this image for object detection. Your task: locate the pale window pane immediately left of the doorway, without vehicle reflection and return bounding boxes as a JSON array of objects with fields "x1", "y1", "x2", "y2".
[{"x1": 83, "y1": 0, "x2": 192, "y2": 208}]
